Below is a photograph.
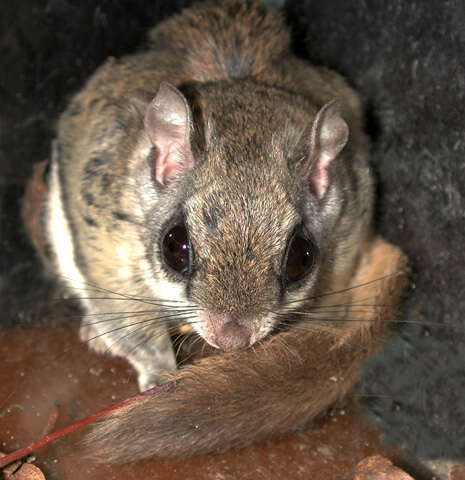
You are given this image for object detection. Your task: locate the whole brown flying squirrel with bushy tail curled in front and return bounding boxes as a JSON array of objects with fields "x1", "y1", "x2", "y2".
[{"x1": 38, "y1": 0, "x2": 402, "y2": 462}]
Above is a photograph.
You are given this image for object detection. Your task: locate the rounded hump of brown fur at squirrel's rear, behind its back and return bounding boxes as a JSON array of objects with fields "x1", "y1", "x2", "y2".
[{"x1": 150, "y1": 0, "x2": 290, "y2": 81}]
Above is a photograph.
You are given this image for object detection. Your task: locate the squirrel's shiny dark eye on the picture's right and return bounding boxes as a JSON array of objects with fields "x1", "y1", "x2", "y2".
[{"x1": 283, "y1": 231, "x2": 315, "y2": 283}]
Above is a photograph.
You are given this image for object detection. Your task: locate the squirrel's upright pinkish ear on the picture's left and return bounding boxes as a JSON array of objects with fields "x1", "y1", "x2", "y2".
[{"x1": 144, "y1": 82, "x2": 194, "y2": 185}]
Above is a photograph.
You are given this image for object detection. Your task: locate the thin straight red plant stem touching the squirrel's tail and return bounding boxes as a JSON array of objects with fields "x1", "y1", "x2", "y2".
[{"x1": 0, "y1": 381, "x2": 175, "y2": 468}]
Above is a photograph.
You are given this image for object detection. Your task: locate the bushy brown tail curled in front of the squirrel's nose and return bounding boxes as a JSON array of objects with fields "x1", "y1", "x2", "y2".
[{"x1": 82, "y1": 239, "x2": 405, "y2": 462}]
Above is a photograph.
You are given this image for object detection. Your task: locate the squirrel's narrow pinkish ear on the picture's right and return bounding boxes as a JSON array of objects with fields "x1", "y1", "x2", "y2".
[{"x1": 299, "y1": 100, "x2": 349, "y2": 199}]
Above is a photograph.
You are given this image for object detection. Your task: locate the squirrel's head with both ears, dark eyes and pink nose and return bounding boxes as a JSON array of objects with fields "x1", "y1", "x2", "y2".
[{"x1": 140, "y1": 80, "x2": 348, "y2": 351}]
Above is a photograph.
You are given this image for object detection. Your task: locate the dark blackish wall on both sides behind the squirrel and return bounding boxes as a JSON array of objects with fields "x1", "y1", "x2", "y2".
[{"x1": 0, "y1": 0, "x2": 465, "y2": 461}]
